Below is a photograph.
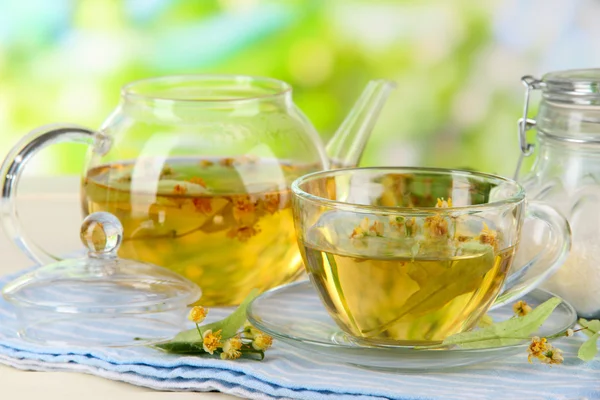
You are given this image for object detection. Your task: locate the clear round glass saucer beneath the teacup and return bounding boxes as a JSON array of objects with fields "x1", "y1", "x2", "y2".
[{"x1": 248, "y1": 281, "x2": 577, "y2": 371}]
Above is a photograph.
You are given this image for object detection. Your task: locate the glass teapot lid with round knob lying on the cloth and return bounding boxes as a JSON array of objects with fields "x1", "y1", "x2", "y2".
[{"x1": 2, "y1": 212, "x2": 201, "y2": 346}]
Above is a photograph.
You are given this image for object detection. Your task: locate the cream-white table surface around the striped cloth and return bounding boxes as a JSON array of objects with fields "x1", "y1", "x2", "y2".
[{"x1": 0, "y1": 177, "x2": 234, "y2": 400}]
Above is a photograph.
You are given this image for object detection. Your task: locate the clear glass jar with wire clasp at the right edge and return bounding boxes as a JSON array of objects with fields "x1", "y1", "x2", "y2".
[{"x1": 515, "y1": 69, "x2": 600, "y2": 318}]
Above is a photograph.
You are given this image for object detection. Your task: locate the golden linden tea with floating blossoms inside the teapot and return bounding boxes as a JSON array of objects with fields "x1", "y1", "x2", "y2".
[{"x1": 82, "y1": 157, "x2": 318, "y2": 304}]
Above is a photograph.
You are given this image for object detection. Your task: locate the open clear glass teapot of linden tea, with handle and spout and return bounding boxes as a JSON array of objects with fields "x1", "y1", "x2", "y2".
[{"x1": 0, "y1": 75, "x2": 394, "y2": 306}]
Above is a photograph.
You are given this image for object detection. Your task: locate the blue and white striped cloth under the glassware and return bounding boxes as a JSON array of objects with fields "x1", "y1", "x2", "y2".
[{"x1": 0, "y1": 270, "x2": 600, "y2": 400}]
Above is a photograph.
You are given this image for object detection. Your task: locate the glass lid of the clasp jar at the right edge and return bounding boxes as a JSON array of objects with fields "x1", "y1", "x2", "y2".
[{"x1": 541, "y1": 68, "x2": 600, "y2": 105}]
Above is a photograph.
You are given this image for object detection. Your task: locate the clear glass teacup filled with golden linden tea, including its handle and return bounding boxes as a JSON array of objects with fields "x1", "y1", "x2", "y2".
[{"x1": 292, "y1": 167, "x2": 570, "y2": 345}]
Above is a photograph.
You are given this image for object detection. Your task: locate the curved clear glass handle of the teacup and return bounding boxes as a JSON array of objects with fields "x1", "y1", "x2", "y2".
[{"x1": 492, "y1": 201, "x2": 571, "y2": 308}]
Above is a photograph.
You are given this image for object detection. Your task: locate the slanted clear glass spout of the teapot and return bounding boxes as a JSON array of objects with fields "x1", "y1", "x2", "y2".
[{"x1": 326, "y1": 79, "x2": 396, "y2": 169}]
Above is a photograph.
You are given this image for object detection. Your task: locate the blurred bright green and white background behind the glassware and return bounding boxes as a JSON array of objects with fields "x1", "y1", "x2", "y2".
[{"x1": 0, "y1": 0, "x2": 600, "y2": 175}]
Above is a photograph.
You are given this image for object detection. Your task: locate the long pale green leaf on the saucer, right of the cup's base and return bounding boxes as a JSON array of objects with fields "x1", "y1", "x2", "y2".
[{"x1": 442, "y1": 297, "x2": 562, "y2": 349}]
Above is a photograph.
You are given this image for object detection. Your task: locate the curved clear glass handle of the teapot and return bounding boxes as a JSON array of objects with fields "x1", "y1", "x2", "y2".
[{"x1": 0, "y1": 124, "x2": 110, "y2": 264}]
